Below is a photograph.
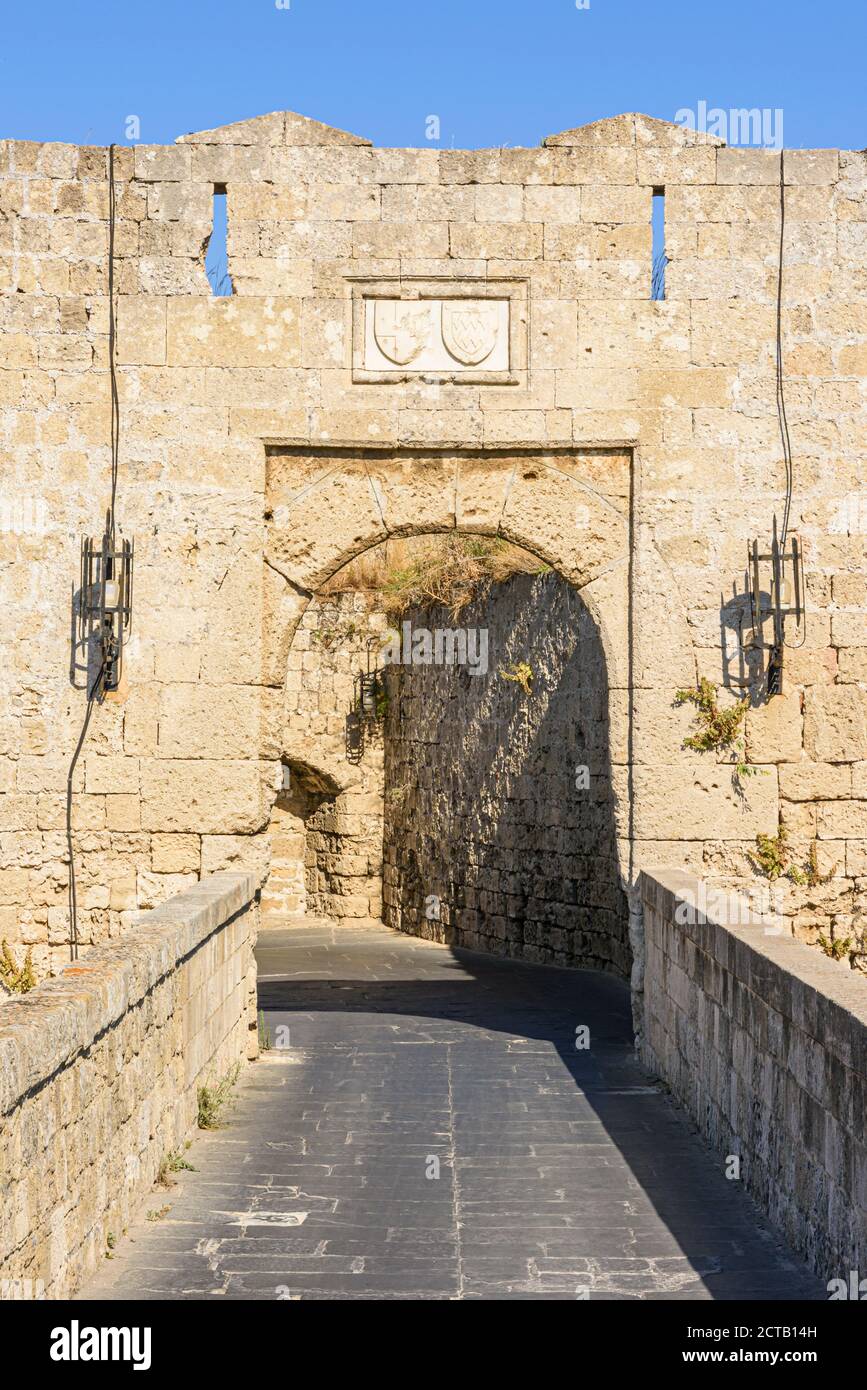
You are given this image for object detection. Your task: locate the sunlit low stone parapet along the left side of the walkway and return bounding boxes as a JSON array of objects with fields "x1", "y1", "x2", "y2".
[{"x1": 0, "y1": 873, "x2": 258, "y2": 1298}]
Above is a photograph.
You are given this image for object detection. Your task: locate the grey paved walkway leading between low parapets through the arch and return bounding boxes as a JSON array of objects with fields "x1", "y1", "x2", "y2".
[{"x1": 82, "y1": 924, "x2": 825, "y2": 1300}]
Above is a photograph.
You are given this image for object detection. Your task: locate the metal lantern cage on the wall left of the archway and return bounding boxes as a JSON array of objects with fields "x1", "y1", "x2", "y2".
[{"x1": 78, "y1": 528, "x2": 133, "y2": 691}]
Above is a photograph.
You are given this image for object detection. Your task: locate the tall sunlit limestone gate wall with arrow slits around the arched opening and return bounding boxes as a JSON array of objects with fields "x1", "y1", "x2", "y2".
[{"x1": 0, "y1": 113, "x2": 867, "y2": 973}]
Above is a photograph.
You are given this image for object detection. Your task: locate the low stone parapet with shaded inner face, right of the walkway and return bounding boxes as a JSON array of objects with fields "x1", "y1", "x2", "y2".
[{"x1": 639, "y1": 872, "x2": 867, "y2": 1280}]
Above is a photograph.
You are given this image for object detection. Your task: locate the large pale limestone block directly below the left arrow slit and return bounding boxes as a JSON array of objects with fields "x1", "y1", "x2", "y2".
[{"x1": 167, "y1": 296, "x2": 302, "y2": 367}]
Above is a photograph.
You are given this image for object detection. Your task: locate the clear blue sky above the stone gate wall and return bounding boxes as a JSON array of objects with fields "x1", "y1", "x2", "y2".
[{"x1": 0, "y1": 0, "x2": 867, "y2": 149}]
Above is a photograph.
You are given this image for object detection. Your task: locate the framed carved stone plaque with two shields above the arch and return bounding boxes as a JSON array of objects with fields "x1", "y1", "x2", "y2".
[{"x1": 353, "y1": 282, "x2": 525, "y2": 384}]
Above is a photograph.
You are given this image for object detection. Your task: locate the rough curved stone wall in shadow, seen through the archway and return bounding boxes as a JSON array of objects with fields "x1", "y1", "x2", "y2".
[{"x1": 383, "y1": 573, "x2": 631, "y2": 979}]
